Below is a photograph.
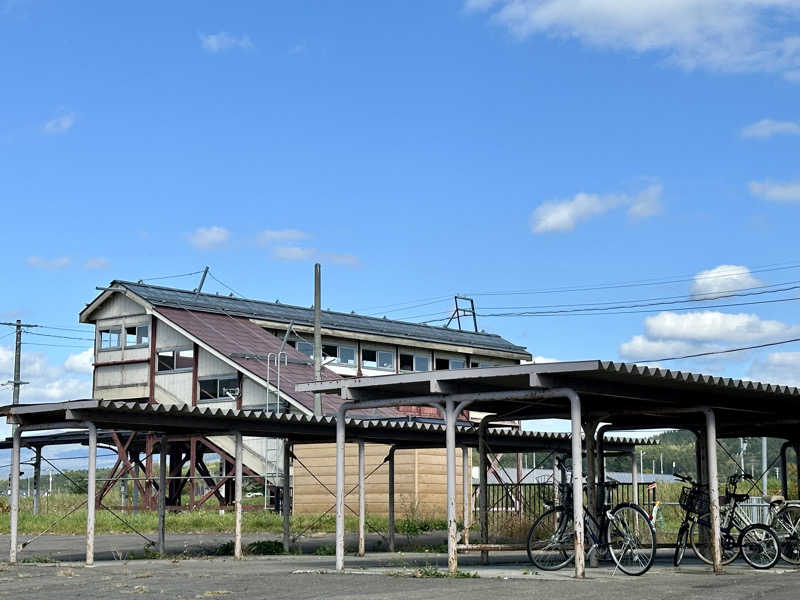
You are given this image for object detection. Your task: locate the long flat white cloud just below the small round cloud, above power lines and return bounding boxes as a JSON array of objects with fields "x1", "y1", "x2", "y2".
[{"x1": 644, "y1": 310, "x2": 800, "y2": 344}]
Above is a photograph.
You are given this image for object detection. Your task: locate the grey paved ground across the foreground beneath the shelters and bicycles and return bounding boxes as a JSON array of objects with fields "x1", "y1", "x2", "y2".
[{"x1": 0, "y1": 534, "x2": 800, "y2": 600}]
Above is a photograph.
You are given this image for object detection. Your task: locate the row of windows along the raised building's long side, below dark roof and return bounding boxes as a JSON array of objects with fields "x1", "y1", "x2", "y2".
[{"x1": 295, "y1": 340, "x2": 472, "y2": 371}]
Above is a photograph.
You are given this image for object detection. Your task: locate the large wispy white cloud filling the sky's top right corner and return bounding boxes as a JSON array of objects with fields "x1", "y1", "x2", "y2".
[{"x1": 465, "y1": 0, "x2": 800, "y2": 80}]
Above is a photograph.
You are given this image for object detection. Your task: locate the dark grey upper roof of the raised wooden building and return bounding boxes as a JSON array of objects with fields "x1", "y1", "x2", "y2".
[{"x1": 111, "y1": 280, "x2": 530, "y2": 358}]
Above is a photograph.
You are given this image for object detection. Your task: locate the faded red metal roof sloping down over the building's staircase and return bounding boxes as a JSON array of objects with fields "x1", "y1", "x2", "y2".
[{"x1": 155, "y1": 307, "x2": 405, "y2": 418}]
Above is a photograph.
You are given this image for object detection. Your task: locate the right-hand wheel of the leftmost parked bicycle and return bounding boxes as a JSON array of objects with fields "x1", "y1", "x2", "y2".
[{"x1": 606, "y1": 504, "x2": 656, "y2": 575}]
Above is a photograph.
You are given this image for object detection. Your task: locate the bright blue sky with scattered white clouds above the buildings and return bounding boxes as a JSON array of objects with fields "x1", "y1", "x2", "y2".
[{"x1": 0, "y1": 0, "x2": 800, "y2": 460}]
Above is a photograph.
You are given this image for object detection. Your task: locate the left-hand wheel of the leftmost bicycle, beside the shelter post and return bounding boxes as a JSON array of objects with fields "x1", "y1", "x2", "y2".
[{"x1": 527, "y1": 507, "x2": 575, "y2": 571}]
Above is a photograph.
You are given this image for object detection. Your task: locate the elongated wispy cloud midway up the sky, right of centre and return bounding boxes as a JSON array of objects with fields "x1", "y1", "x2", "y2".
[{"x1": 530, "y1": 184, "x2": 663, "y2": 233}]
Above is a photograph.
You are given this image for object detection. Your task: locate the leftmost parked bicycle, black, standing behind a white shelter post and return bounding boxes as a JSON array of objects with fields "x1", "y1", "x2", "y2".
[{"x1": 526, "y1": 482, "x2": 656, "y2": 576}]
